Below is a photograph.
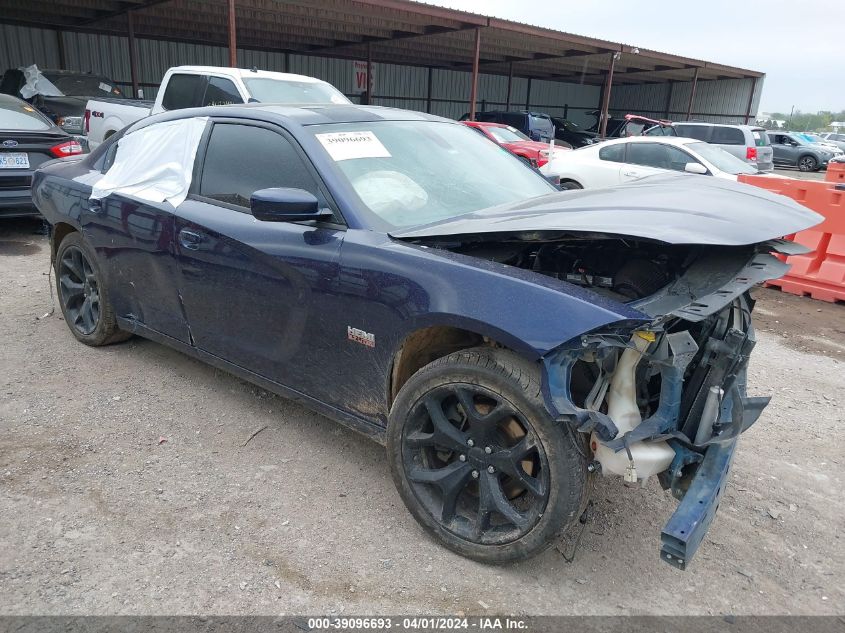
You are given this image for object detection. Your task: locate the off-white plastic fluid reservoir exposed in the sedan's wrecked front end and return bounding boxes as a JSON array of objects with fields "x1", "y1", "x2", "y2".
[{"x1": 590, "y1": 334, "x2": 675, "y2": 482}]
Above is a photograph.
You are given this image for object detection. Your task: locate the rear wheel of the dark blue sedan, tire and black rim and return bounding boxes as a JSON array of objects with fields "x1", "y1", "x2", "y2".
[{"x1": 54, "y1": 233, "x2": 132, "y2": 347}]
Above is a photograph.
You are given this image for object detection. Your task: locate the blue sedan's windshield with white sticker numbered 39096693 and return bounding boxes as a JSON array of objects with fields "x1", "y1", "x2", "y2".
[{"x1": 309, "y1": 121, "x2": 556, "y2": 231}]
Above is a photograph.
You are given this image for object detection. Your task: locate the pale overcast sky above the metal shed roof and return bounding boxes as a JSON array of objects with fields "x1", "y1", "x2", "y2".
[{"x1": 418, "y1": 0, "x2": 845, "y2": 113}]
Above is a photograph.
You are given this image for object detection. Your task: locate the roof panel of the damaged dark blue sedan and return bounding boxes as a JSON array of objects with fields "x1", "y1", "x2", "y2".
[{"x1": 132, "y1": 103, "x2": 458, "y2": 130}]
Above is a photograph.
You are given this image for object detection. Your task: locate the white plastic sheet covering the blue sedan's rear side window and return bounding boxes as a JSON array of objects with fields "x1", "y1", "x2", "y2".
[{"x1": 91, "y1": 117, "x2": 208, "y2": 207}]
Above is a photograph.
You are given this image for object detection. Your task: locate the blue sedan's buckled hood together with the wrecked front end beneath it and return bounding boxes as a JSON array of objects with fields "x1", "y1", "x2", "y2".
[{"x1": 390, "y1": 177, "x2": 821, "y2": 569}]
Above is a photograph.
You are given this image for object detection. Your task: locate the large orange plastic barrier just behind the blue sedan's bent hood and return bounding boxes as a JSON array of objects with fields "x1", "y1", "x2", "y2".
[{"x1": 739, "y1": 172, "x2": 845, "y2": 302}]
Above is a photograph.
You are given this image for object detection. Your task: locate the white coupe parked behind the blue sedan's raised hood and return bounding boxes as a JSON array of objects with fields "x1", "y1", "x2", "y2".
[{"x1": 540, "y1": 136, "x2": 776, "y2": 189}]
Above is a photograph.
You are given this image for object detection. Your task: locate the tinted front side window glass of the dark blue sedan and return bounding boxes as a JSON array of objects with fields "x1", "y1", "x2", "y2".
[{"x1": 199, "y1": 123, "x2": 328, "y2": 208}]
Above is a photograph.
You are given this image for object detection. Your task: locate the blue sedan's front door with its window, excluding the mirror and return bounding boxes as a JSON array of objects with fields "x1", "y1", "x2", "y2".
[{"x1": 176, "y1": 121, "x2": 345, "y2": 401}]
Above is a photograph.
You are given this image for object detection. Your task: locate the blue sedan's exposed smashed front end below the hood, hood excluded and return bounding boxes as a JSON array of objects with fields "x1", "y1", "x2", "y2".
[{"x1": 543, "y1": 240, "x2": 803, "y2": 569}]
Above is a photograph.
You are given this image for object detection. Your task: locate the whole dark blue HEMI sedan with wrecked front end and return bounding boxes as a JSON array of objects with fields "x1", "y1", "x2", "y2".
[{"x1": 33, "y1": 104, "x2": 819, "y2": 568}]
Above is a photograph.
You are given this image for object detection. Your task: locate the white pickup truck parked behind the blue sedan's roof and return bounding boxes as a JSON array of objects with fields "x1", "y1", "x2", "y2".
[{"x1": 84, "y1": 66, "x2": 350, "y2": 150}]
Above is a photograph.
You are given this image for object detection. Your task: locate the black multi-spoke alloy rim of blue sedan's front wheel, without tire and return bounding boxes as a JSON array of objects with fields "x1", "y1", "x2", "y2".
[{"x1": 402, "y1": 384, "x2": 549, "y2": 545}]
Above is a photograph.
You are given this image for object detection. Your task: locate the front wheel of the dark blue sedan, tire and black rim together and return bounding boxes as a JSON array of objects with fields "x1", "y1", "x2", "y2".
[{"x1": 387, "y1": 347, "x2": 589, "y2": 564}]
